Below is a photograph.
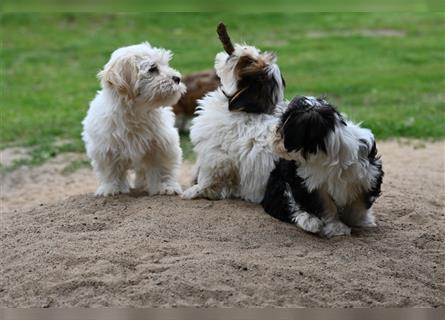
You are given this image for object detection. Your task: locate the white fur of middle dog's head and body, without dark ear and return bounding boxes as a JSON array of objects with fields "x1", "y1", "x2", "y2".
[{"x1": 183, "y1": 44, "x2": 284, "y2": 203}]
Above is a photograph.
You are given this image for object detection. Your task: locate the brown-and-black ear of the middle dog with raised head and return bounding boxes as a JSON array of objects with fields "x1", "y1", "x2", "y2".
[{"x1": 229, "y1": 56, "x2": 278, "y2": 113}]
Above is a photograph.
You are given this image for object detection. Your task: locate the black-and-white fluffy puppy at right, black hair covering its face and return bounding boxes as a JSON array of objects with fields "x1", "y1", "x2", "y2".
[{"x1": 262, "y1": 97, "x2": 383, "y2": 237}]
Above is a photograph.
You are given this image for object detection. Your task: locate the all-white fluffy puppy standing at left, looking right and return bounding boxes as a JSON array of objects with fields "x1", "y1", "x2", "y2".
[{"x1": 82, "y1": 42, "x2": 185, "y2": 196}]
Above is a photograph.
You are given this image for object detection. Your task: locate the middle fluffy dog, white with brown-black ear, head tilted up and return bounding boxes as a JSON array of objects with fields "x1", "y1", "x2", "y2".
[{"x1": 183, "y1": 25, "x2": 284, "y2": 203}]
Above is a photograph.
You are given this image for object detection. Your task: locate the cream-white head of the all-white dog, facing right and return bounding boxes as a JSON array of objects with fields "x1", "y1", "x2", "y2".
[{"x1": 98, "y1": 42, "x2": 186, "y2": 108}]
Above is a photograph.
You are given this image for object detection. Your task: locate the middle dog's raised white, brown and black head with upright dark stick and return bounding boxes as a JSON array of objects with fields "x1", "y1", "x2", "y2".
[{"x1": 215, "y1": 24, "x2": 285, "y2": 113}]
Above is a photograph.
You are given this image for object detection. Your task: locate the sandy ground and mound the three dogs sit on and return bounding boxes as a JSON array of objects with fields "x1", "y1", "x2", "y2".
[{"x1": 0, "y1": 141, "x2": 445, "y2": 307}]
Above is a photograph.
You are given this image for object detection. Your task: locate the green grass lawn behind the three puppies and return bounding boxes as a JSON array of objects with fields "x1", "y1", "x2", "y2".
[{"x1": 0, "y1": 13, "x2": 445, "y2": 163}]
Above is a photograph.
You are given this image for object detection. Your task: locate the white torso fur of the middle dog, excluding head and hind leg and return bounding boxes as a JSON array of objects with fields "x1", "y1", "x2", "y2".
[{"x1": 190, "y1": 90, "x2": 277, "y2": 203}]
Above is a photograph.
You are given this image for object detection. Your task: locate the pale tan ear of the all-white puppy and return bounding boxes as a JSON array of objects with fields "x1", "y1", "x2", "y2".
[{"x1": 98, "y1": 57, "x2": 139, "y2": 101}]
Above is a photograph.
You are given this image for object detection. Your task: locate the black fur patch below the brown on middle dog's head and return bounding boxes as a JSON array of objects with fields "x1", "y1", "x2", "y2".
[{"x1": 229, "y1": 69, "x2": 279, "y2": 114}]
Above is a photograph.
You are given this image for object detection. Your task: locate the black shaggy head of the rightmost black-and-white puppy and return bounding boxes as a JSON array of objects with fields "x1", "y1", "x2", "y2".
[{"x1": 272, "y1": 96, "x2": 346, "y2": 161}]
